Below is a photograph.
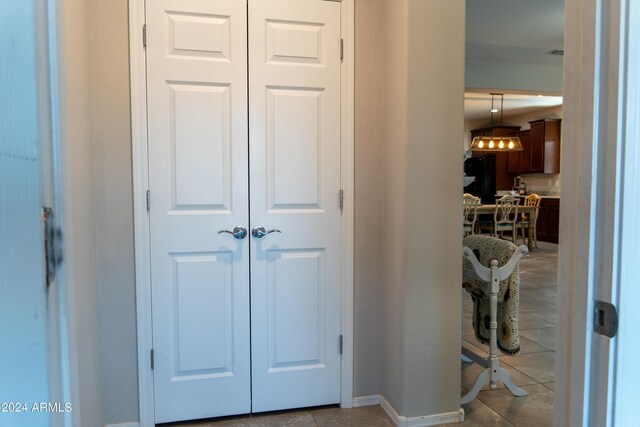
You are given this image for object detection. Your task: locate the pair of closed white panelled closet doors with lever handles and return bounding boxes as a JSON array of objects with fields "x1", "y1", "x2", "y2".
[{"x1": 146, "y1": 0, "x2": 342, "y2": 422}]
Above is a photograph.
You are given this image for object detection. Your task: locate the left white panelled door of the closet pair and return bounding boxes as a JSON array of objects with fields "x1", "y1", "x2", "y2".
[{"x1": 147, "y1": 0, "x2": 250, "y2": 422}]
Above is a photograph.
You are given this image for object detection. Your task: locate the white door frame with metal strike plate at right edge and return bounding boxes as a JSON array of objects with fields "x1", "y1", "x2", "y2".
[{"x1": 554, "y1": 0, "x2": 640, "y2": 426}]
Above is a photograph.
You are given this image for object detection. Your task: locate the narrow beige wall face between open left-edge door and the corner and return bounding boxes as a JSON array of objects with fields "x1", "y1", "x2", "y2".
[{"x1": 56, "y1": 0, "x2": 103, "y2": 426}]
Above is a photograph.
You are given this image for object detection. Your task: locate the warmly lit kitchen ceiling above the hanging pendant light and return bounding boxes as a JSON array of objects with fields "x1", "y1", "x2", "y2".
[{"x1": 464, "y1": 92, "x2": 562, "y2": 121}]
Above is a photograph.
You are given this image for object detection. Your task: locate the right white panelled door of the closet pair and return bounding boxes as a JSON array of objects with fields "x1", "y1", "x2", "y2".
[{"x1": 249, "y1": 0, "x2": 342, "y2": 412}]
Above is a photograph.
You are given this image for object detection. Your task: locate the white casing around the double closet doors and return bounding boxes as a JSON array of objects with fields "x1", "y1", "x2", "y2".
[{"x1": 129, "y1": 0, "x2": 355, "y2": 427}]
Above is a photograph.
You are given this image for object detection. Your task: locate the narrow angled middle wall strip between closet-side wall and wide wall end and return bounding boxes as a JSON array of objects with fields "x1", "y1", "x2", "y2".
[{"x1": 380, "y1": 0, "x2": 408, "y2": 410}]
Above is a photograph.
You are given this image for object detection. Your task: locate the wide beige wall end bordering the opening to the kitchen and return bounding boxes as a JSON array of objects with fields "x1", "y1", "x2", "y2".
[{"x1": 401, "y1": 0, "x2": 465, "y2": 417}]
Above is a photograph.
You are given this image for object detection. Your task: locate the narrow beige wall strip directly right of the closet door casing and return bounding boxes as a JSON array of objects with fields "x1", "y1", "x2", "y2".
[{"x1": 353, "y1": 0, "x2": 385, "y2": 396}]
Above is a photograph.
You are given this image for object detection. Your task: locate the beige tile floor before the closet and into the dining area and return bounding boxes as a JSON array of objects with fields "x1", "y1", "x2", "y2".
[{"x1": 164, "y1": 242, "x2": 558, "y2": 427}]
